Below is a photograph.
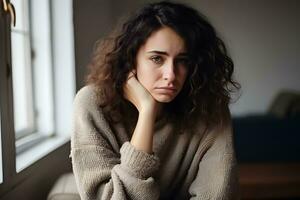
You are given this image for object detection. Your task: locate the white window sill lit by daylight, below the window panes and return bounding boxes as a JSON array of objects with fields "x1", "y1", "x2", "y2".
[{"x1": 16, "y1": 136, "x2": 70, "y2": 173}]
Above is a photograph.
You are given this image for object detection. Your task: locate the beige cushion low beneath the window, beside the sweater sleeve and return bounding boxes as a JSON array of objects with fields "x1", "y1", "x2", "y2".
[{"x1": 47, "y1": 173, "x2": 80, "y2": 200}]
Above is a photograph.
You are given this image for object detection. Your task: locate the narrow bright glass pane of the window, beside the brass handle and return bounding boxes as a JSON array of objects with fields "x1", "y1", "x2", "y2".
[{"x1": 11, "y1": 0, "x2": 35, "y2": 139}]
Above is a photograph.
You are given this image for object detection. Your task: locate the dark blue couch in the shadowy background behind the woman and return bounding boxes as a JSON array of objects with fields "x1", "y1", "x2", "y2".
[{"x1": 233, "y1": 115, "x2": 300, "y2": 163}]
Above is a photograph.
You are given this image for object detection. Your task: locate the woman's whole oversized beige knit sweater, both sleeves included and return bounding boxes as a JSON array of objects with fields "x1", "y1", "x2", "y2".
[{"x1": 71, "y1": 86, "x2": 238, "y2": 200}]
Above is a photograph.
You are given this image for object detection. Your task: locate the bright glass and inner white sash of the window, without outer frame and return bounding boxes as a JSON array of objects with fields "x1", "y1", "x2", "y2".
[{"x1": 11, "y1": 0, "x2": 54, "y2": 154}]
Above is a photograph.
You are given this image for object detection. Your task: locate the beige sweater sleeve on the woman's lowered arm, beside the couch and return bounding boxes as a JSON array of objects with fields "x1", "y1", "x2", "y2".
[{"x1": 189, "y1": 116, "x2": 239, "y2": 200}]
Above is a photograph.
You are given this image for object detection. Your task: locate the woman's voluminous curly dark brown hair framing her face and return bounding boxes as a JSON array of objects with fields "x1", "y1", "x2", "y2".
[{"x1": 87, "y1": 1, "x2": 240, "y2": 128}]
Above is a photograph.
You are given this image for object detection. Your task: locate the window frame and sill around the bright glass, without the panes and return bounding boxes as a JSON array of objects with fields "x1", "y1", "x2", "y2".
[{"x1": 0, "y1": 0, "x2": 75, "y2": 192}]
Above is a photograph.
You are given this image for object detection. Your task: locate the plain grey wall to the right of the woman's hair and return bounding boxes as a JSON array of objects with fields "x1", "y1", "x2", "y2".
[{"x1": 184, "y1": 0, "x2": 300, "y2": 115}]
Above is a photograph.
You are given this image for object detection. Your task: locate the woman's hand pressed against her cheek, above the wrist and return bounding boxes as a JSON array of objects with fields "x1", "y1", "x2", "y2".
[{"x1": 124, "y1": 71, "x2": 157, "y2": 113}]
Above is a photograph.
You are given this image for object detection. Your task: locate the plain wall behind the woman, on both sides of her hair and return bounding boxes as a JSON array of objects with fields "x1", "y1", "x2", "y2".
[{"x1": 75, "y1": 0, "x2": 300, "y2": 115}]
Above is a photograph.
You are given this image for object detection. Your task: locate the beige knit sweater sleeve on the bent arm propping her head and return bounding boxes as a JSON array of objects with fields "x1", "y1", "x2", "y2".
[{"x1": 71, "y1": 86, "x2": 159, "y2": 200}]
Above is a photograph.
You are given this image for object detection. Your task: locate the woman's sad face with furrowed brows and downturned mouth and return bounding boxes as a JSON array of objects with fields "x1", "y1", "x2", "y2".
[{"x1": 136, "y1": 27, "x2": 188, "y2": 103}]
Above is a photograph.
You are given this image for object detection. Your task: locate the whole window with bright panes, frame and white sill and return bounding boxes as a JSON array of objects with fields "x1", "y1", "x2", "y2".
[{"x1": 0, "y1": 0, "x2": 75, "y2": 191}]
